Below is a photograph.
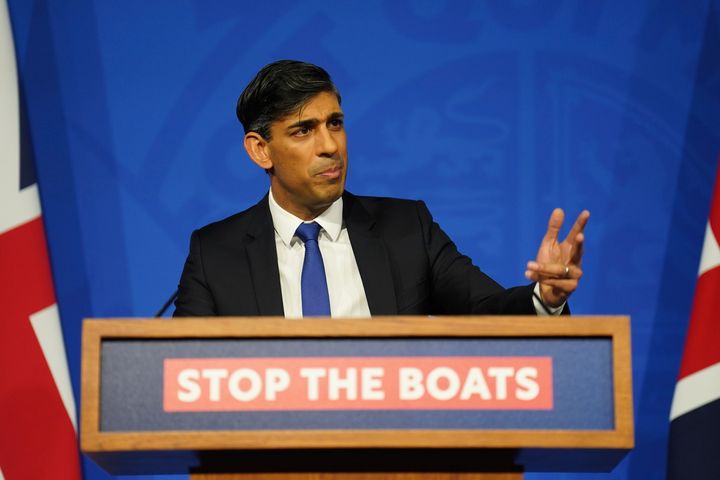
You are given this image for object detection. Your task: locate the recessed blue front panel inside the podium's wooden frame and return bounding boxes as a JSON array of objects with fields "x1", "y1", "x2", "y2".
[{"x1": 100, "y1": 337, "x2": 614, "y2": 432}]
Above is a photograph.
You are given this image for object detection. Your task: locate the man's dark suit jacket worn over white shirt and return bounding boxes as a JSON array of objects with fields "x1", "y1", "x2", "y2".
[{"x1": 175, "y1": 192, "x2": 535, "y2": 316}]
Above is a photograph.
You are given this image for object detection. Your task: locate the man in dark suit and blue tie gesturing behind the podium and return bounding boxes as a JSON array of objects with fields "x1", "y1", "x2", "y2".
[{"x1": 175, "y1": 60, "x2": 589, "y2": 318}]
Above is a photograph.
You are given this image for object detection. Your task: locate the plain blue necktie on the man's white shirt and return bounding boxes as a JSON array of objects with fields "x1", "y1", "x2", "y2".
[{"x1": 295, "y1": 222, "x2": 330, "y2": 317}]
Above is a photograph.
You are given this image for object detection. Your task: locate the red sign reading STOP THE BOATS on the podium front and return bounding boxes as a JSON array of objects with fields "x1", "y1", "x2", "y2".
[{"x1": 164, "y1": 357, "x2": 553, "y2": 412}]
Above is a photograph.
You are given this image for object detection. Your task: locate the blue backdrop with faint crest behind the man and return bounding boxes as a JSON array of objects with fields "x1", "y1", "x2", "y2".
[{"x1": 9, "y1": 0, "x2": 720, "y2": 480}]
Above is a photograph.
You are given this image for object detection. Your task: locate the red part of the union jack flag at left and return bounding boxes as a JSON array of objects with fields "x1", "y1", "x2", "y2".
[{"x1": 0, "y1": 218, "x2": 80, "y2": 480}]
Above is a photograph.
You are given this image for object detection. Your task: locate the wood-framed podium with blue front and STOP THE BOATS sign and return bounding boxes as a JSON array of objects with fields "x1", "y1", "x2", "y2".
[{"x1": 81, "y1": 316, "x2": 634, "y2": 480}]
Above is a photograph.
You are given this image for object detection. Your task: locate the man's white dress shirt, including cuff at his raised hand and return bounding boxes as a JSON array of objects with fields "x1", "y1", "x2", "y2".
[{"x1": 269, "y1": 189, "x2": 564, "y2": 318}]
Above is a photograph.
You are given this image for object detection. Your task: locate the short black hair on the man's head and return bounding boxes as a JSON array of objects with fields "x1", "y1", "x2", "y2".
[{"x1": 236, "y1": 60, "x2": 340, "y2": 140}]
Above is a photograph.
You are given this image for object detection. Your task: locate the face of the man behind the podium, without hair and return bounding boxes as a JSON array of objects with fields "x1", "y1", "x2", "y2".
[{"x1": 265, "y1": 92, "x2": 347, "y2": 220}]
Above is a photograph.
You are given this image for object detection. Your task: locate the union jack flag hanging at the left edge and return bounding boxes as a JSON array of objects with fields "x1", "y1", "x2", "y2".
[{"x1": 0, "y1": 0, "x2": 81, "y2": 480}]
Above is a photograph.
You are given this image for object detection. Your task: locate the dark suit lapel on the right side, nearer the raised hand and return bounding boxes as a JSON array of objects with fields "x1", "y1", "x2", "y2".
[{"x1": 343, "y1": 192, "x2": 397, "y2": 315}]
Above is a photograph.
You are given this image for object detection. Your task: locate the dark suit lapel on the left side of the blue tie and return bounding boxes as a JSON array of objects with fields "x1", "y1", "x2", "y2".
[{"x1": 246, "y1": 195, "x2": 284, "y2": 316}]
